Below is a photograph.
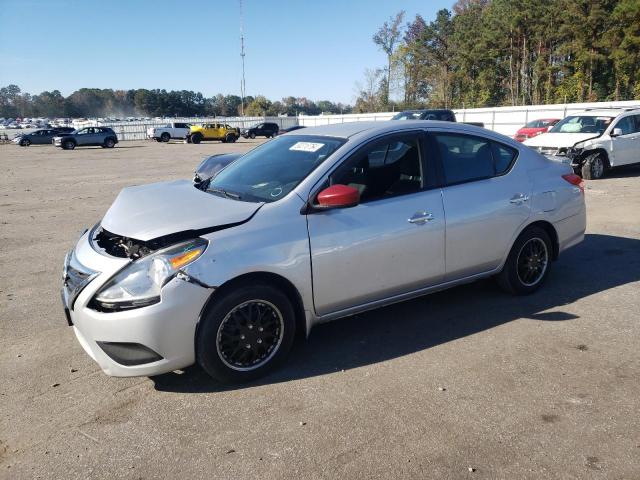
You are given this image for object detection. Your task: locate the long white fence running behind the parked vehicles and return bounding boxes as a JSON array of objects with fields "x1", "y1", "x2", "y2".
[{"x1": 74, "y1": 100, "x2": 640, "y2": 140}]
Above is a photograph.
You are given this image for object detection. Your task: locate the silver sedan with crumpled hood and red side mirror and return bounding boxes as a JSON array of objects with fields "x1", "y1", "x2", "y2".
[{"x1": 62, "y1": 121, "x2": 586, "y2": 383}]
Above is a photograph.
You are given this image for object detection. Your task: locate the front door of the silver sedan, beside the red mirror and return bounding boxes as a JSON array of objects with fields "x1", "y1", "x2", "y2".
[{"x1": 307, "y1": 132, "x2": 445, "y2": 315}]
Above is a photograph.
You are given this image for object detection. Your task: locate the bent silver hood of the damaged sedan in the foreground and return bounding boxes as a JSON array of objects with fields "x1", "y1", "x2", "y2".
[{"x1": 102, "y1": 180, "x2": 263, "y2": 242}]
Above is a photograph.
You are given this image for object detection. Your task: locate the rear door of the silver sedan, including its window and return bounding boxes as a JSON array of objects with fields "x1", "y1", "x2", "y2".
[{"x1": 433, "y1": 132, "x2": 533, "y2": 281}]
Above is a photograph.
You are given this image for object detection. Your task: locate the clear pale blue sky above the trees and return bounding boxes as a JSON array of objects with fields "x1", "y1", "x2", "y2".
[{"x1": 0, "y1": 0, "x2": 453, "y2": 103}]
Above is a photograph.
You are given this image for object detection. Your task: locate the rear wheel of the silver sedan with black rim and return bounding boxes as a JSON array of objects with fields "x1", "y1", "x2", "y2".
[{"x1": 496, "y1": 226, "x2": 553, "y2": 295}]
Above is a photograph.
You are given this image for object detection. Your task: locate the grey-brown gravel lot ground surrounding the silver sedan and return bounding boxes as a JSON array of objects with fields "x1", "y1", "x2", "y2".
[{"x1": 0, "y1": 140, "x2": 640, "y2": 479}]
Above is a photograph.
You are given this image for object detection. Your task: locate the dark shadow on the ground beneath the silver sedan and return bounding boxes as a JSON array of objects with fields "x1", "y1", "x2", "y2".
[{"x1": 151, "y1": 234, "x2": 640, "y2": 393}]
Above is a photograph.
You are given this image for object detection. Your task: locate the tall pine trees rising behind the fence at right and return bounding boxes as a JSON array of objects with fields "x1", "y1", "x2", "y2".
[{"x1": 354, "y1": 0, "x2": 640, "y2": 112}]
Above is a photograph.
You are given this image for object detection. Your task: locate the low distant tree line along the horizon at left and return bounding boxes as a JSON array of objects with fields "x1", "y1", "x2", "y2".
[{"x1": 0, "y1": 85, "x2": 351, "y2": 118}]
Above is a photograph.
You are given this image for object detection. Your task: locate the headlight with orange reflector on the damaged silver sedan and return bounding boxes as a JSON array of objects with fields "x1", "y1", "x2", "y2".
[{"x1": 92, "y1": 238, "x2": 208, "y2": 311}]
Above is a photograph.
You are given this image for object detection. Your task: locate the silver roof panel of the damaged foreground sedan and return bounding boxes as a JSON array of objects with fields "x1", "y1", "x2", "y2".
[{"x1": 287, "y1": 120, "x2": 493, "y2": 138}]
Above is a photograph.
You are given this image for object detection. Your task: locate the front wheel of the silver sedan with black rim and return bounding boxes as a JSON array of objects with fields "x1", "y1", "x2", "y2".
[{"x1": 196, "y1": 284, "x2": 296, "y2": 384}]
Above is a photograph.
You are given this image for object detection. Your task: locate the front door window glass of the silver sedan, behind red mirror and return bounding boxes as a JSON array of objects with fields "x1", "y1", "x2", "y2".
[{"x1": 331, "y1": 137, "x2": 423, "y2": 202}]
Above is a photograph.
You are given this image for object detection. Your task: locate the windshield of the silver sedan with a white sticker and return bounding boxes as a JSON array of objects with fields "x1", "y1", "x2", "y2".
[{"x1": 207, "y1": 135, "x2": 346, "y2": 202}]
